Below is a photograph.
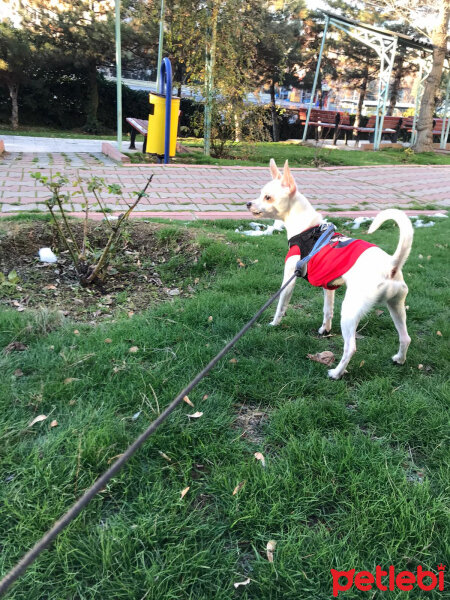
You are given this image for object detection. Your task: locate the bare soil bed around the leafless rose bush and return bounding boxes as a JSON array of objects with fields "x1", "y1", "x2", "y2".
[{"x1": 0, "y1": 221, "x2": 202, "y2": 321}]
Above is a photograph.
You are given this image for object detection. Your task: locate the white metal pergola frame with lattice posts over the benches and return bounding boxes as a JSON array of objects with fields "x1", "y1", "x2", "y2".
[{"x1": 303, "y1": 11, "x2": 450, "y2": 150}]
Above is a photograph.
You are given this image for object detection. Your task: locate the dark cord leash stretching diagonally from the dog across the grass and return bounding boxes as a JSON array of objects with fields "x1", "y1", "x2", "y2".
[{"x1": 0, "y1": 274, "x2": 298, "y2": 596}]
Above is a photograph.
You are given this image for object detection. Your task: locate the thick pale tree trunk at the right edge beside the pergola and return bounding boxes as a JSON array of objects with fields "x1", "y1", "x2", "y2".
[{"x1": 413, "y1": 0, "x2": 450, "y2": 152}]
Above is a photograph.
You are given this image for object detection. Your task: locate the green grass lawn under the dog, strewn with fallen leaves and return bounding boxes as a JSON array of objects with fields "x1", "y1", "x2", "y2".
[{"x1": 0, "y1": 214, "x2": 450, "y2": 600}]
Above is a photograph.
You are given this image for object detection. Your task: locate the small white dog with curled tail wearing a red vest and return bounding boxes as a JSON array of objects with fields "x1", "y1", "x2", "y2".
[{"x1": 247, "y1": 159, "x2": 413, "y2": 379}]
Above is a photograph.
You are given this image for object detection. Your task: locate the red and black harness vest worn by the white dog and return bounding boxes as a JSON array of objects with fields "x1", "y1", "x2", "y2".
[{"x1": 285, "y1": 225, "x2": 375, "y2": 290}]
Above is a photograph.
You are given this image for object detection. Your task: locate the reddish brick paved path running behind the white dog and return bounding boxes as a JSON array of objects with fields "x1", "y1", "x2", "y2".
[{"x1": 0, "y1": 153, "x2": 450, "y2": 219}]
